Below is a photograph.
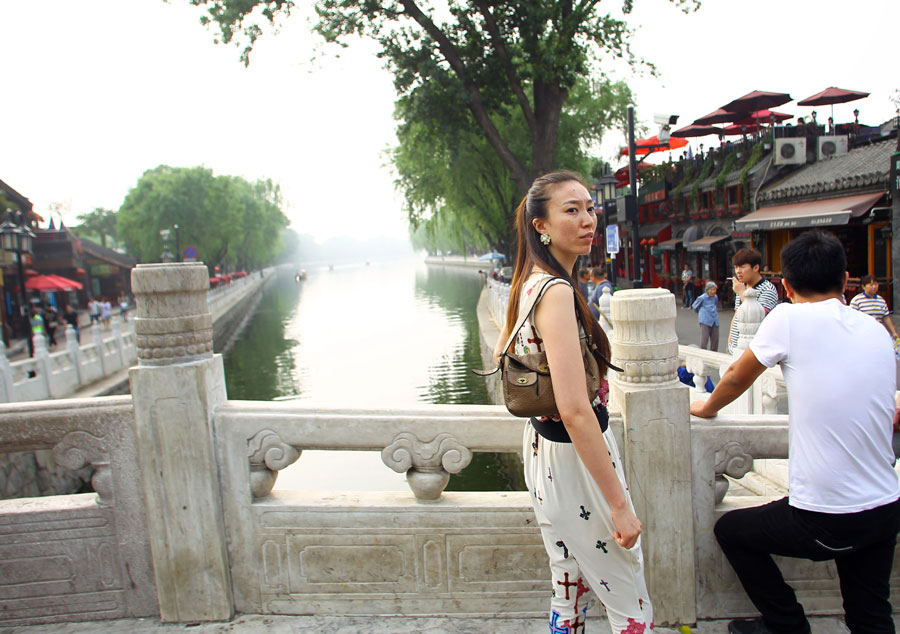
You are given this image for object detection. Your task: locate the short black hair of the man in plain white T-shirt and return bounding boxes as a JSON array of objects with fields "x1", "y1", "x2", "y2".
[{"x1": 781, "y1": 229, "x2": 847, "y2": 295}]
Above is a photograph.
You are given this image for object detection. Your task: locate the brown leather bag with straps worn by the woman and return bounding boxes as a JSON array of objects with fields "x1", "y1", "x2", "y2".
[{"x1": 472, "y1": 277, "x2": 618, "y2": 417}]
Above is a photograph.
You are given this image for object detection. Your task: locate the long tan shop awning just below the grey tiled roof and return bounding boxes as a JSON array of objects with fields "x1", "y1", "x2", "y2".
[{"x1": 735, "y1": 193, "x2": 884, "y2": 231}]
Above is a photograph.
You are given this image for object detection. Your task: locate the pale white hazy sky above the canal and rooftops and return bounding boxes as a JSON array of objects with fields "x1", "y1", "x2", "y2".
[{"x1": 0, "y1": 0, "x2": 900, "y2": 238}]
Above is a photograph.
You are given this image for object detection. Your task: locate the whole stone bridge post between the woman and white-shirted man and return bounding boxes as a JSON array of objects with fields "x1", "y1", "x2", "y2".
[{"x1": 610, "y1": 288, "x2": 697, "y2": 625}]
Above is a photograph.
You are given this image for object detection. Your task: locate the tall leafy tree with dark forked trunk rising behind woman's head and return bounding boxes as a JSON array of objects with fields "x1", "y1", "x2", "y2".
[{"x1": 190, "y1": 0, "x2": 699, "y2": 195}]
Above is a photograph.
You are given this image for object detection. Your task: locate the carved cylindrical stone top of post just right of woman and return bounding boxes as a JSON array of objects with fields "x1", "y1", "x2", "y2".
[{"x1": 610, "y1": 288, "x2": 678, "y2": 387}]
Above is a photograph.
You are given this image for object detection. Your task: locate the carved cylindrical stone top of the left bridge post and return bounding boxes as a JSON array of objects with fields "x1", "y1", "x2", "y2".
[{"x1": 131, "y1": 262, "x2": 213, "y2": 366}]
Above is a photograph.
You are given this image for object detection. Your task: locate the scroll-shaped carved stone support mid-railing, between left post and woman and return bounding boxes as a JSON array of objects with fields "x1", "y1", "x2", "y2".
[{"x1": 381, "y1": 432, "x2": 472, "y2": 501}]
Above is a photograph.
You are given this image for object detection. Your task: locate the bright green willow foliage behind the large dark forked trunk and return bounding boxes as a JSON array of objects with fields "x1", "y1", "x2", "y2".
[{"x1": 392, "y1": 74, "x2": 631, "y2": 253}]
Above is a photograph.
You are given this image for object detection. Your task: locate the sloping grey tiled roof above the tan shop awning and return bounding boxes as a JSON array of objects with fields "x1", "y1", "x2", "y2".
[{"x1": 759, "y1": 138, "x2": 897, "y2": 202}]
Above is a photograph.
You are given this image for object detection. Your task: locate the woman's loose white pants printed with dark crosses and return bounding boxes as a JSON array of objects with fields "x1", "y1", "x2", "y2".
[{"x1": 522, "y1": 423, "x2": 653, "y2": 634}]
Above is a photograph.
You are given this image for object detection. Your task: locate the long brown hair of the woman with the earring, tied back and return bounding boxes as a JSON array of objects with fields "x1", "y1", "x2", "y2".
[{"x1": 506, "y1": 170, "x2": 610, "y2": 375}]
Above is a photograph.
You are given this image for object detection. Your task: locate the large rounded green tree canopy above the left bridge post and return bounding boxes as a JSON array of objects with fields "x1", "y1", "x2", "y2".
[{"x1": 116, "y1": 165, "x2": 288, "y2": 269}]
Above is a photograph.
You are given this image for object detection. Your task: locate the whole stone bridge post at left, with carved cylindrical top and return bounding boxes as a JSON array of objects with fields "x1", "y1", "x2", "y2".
[{"x1": 130, "y1": 263, "x2": 234, "y2": 622}]
